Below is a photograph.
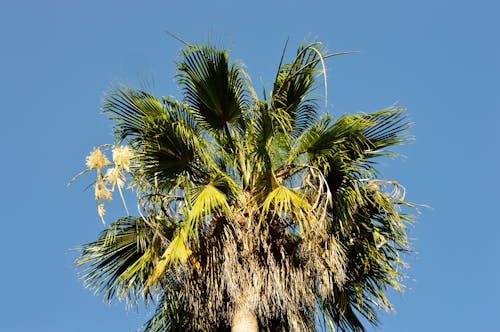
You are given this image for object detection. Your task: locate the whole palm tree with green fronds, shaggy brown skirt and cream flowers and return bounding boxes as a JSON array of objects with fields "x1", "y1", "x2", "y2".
[{"x1": 77, "y1": 42, "x2": 411, "y2": 331}]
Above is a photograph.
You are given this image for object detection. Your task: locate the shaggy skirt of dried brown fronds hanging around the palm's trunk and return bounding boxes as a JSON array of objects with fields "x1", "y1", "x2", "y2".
[{"x1": 177, "y1": 220, "x2": 345, "y2": 332}]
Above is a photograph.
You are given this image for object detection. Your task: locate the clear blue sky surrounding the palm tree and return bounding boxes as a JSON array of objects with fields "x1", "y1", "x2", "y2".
[{"x1": 0, "y1": 0, "x2": 500, "y2": 332}]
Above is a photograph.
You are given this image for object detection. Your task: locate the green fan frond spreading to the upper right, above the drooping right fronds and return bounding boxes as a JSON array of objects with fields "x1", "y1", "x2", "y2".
[{"x1": 290, "y1": 108, "x2": 409, "y2": 196}]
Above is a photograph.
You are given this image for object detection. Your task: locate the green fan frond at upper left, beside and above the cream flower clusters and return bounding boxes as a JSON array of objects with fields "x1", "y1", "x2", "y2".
[{"x1": 104, "y1": 87, "x2": 207, "y2": 188}]
